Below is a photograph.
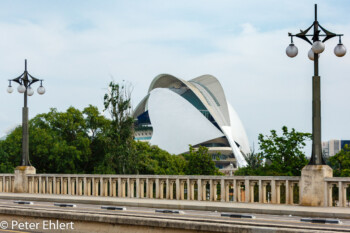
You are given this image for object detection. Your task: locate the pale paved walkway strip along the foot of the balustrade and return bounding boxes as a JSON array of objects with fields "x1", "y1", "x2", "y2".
[{"x1": 0, "y1": 193, "x2": 350, "y2": 219}]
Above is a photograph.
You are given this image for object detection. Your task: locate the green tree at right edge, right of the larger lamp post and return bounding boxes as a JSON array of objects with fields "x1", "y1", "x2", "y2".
[{"x1": 329, "y1": 145, "x2": 350, "y2": 177}]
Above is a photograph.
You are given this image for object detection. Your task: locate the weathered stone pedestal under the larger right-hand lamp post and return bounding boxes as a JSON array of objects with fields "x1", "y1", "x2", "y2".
[{"x1": 300, "y1": 165, "x2": 333, "y2": 206}]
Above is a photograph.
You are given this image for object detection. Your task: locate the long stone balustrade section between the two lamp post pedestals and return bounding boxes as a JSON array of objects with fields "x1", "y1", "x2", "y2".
[{"x1": 22, "y1": 174, "x2": 300, "y2": 204}]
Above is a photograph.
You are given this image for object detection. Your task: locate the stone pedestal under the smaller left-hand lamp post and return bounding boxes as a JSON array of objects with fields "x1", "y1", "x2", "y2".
[{"x1": 14, "y1": 166, "x2": 36, "y2": 193}]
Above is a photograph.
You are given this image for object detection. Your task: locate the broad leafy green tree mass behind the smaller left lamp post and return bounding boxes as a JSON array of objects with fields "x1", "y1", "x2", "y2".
[{"x1": 0, "y1": 106, "x2": 108, "y2": 173}]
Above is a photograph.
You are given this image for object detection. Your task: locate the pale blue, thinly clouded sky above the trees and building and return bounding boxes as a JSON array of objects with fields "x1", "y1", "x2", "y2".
[{"x1": 0, "y1": 0, "x2": 350, "y2": 154}]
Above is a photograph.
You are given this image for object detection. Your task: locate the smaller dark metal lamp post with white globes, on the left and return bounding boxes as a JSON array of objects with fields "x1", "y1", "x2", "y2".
[{"x1": 7, "y1": 60, "x2": 45, "y2": 166}]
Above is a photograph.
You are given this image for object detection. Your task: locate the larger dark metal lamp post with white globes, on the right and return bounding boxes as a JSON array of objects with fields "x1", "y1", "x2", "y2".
[{"x1": 286, "y1": 4, "x2": 346, "y2": 165}]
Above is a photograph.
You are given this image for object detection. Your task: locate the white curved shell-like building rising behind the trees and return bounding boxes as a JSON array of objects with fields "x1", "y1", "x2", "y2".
[{"x1": 133, "y1": 74, "x2": 250, "y2": 169}]
